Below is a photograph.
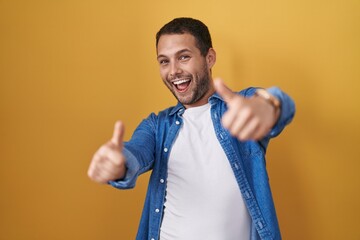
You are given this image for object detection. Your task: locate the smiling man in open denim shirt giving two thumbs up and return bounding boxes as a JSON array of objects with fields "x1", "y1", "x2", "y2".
[{"x1": 88, "y1": 18, "x2": 295, "y2": 240}]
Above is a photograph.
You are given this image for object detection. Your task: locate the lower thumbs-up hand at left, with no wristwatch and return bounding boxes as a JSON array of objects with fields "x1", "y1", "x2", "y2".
[{"x1": 88, "y1": 121, "x2": 126, "y2": 183}]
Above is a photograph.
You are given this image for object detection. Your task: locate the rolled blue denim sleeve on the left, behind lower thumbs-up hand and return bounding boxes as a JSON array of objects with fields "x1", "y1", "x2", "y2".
[{"x1": 109, "y1": 114, "x2": 156, "y2": 189}]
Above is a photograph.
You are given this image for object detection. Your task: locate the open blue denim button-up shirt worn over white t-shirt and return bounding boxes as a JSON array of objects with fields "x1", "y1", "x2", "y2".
[{"x1": 109, "y1": 88, "x2": 295, "y2": 240}]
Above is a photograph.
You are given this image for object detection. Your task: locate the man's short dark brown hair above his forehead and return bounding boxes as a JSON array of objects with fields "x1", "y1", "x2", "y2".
[{"x1": 156, "y1": 17, "x2": 212, "y2": 56}]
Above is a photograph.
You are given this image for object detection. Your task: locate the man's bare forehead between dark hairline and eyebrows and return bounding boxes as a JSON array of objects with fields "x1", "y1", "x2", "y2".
[{"x1": 157, "y1": 33, "x2": 200, "y2": 56}]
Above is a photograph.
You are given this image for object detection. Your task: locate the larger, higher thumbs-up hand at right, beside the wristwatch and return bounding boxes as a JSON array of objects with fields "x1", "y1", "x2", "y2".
[{"x1": 214, "y1": 79, "x2": 279, "y2": 141}]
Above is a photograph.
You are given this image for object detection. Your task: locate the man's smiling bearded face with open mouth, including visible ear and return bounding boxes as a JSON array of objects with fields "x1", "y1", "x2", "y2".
[{"x1": 157, "y1": 33, "x2": 215, "y2": 108}]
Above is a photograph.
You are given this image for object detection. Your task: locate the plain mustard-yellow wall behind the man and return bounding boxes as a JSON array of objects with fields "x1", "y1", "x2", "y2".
[{"x1": 0, "y1": 0, "x2": 360, "y2": 240}]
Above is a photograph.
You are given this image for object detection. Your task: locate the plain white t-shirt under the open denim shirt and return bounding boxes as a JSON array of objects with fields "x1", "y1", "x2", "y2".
[{"x1": 160, "y1": 104, "x2": 251, "y2": 240}]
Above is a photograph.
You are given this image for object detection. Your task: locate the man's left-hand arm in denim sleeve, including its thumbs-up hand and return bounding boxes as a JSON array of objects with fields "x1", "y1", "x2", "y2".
[{"x1": 88, "y1": 114, "x2": 155, "y2": 189}]
